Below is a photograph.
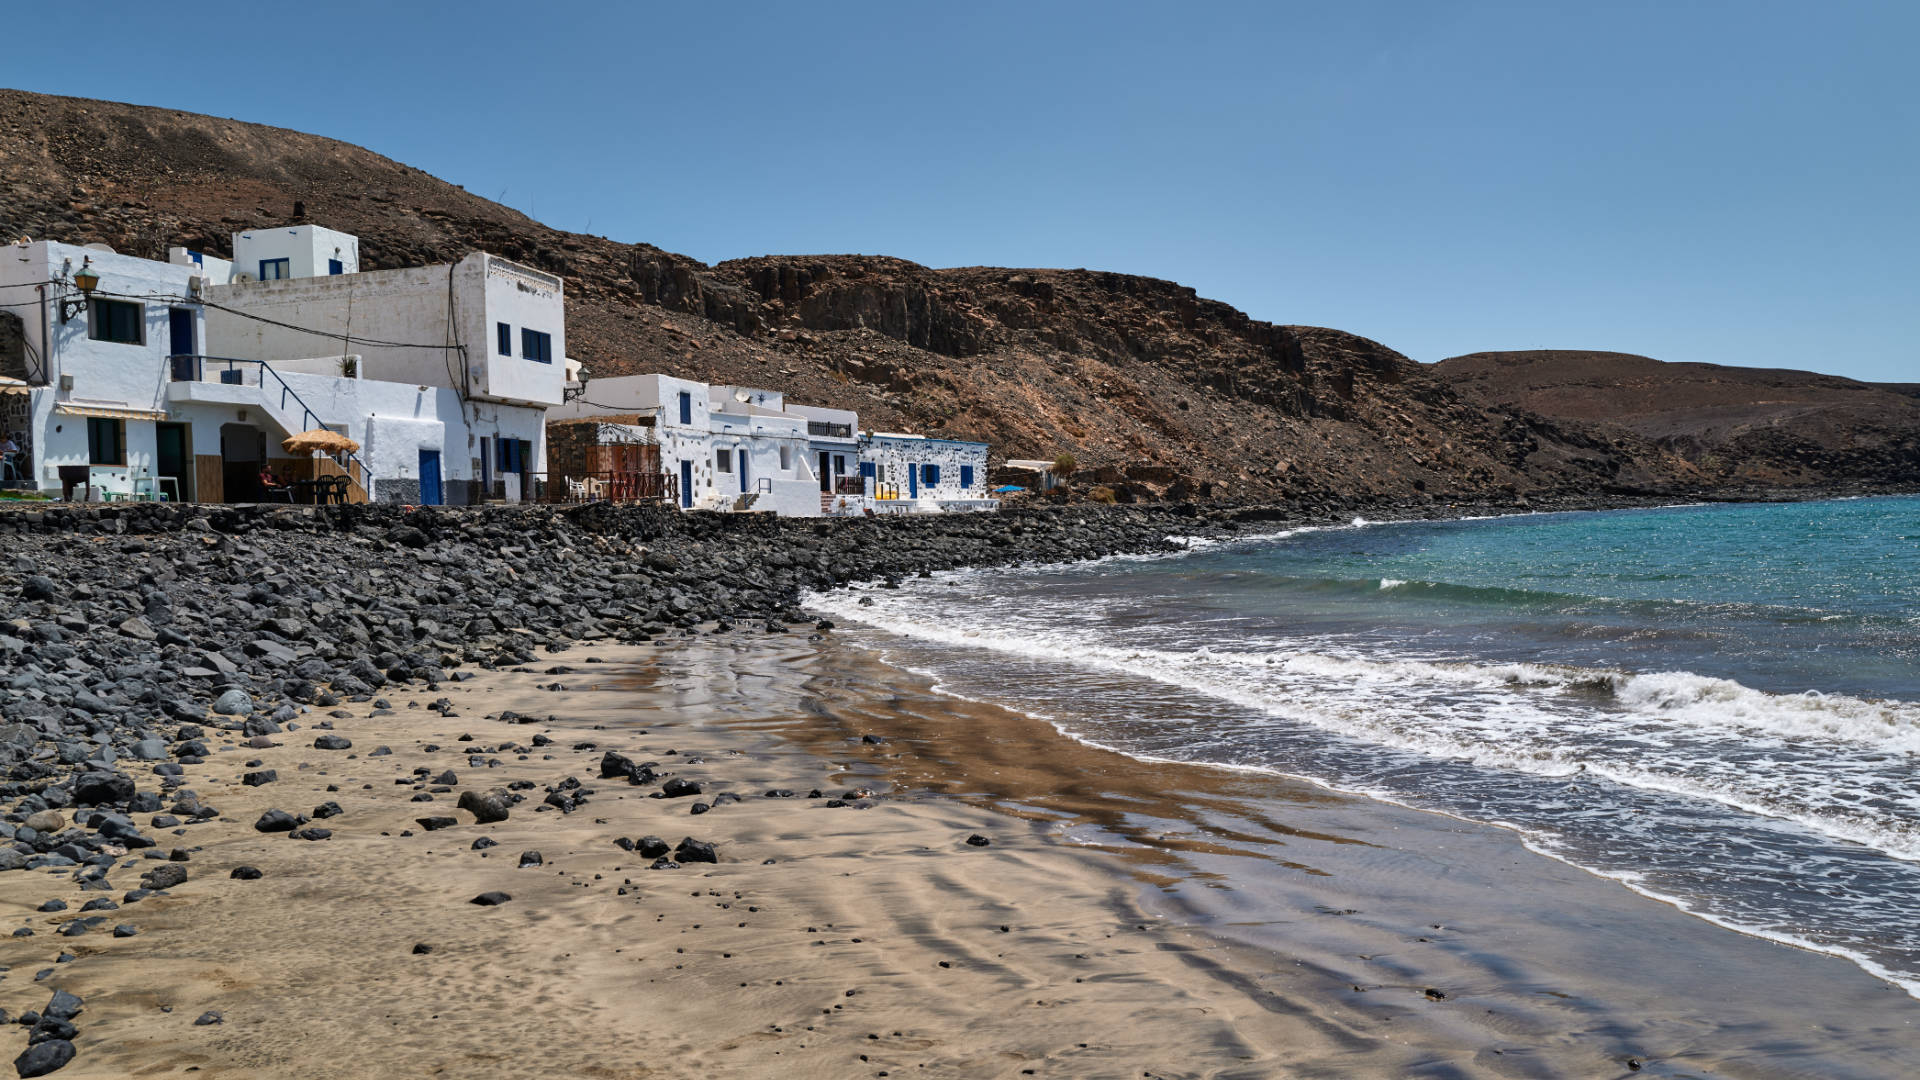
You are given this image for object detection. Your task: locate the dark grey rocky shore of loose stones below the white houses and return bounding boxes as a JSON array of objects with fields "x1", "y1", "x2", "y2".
[{"x1": 0, "y1": 486, "x2": 1904, "y2": 1076}]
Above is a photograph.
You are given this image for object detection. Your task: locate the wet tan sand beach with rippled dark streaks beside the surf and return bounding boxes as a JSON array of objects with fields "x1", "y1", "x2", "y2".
[{"x1": 0, "y1": 636, "x2": 1920, "y2": 1078}]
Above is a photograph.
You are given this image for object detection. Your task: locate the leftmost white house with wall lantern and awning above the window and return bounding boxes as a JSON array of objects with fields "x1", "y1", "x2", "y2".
[{"x1": 0, "y1": 240, "x2": 205, "y2": 498}]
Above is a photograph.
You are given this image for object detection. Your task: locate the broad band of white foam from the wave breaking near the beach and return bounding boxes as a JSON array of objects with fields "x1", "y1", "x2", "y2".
[{"x1": 808, "y1": 590, "x2": 1920, "y2": 861}]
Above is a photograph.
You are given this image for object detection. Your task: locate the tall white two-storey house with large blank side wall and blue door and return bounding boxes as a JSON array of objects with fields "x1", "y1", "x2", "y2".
[{"x1": 211, "y1": 245, "x2": 566, "y2": 505}]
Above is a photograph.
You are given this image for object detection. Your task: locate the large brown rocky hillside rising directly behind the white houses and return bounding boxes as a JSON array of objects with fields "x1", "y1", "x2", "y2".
[{"x1": 0, "y1": 90, "x2": 1896, "y2": 500}]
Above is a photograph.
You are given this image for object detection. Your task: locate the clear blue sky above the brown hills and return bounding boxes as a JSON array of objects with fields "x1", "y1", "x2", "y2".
[{"x1": 0, "y1": 0, "x2": 1920, "y2": 380}]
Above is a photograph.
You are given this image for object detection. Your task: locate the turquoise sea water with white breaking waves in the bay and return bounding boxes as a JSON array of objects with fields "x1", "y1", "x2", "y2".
[{"x1": 810, "y1": 498, "x2": 1920, "y2": 995}]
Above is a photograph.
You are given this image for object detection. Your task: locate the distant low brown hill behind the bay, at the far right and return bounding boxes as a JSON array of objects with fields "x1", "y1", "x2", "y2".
[{"x1": 1434, "y1": 350, "x2": 1920, "y2": 488}]
